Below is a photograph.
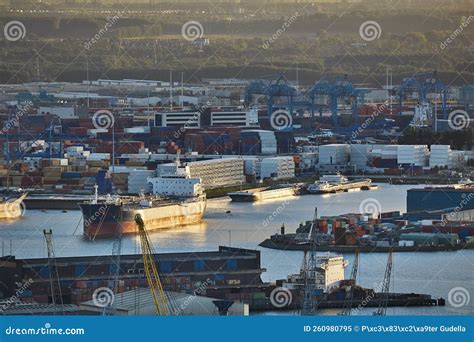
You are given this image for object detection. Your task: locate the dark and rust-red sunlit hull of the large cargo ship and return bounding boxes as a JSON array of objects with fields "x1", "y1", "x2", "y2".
[{"x1": 79, "y1": 200, "x2": 206, "y2": 239}]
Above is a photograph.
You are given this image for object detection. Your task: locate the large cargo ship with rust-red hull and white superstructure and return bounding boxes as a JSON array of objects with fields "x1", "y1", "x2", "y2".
[{"x1": 79, "y1": 166, "x2": 206, "y2": 239}]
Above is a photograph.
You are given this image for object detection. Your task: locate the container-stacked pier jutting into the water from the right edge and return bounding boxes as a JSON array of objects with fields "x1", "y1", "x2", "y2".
[{"x1": 260, "y1": 208, "x2": 474, "y2": 253}]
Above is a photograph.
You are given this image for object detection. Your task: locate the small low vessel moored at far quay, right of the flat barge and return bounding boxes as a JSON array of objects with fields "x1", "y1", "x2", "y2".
[{"x1": 306, "y1": 174, "x2": 372, "y2": 194}]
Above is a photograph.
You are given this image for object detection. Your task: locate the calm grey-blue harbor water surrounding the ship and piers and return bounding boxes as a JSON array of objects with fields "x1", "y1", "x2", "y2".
[{"x1": 0, "y1": 184, "x2": 474, "y2": 315}]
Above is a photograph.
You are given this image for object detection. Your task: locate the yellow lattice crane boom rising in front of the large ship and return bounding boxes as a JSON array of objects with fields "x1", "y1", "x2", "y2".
[{"x1": 135, "y1": 214, "x2": 177, "y2": 316}]
